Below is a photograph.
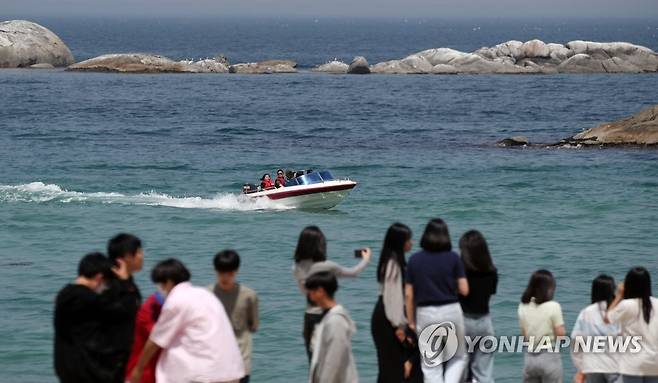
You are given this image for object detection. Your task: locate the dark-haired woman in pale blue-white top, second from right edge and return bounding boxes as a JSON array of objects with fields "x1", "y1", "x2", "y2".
[{"x1": 571, "y1": 274, "x2": 619, "y2": 383}]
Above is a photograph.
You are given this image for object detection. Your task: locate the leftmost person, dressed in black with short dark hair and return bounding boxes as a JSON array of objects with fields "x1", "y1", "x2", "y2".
[{"x1": 53, "y1": 253, "x2": 115, "y2": 383}]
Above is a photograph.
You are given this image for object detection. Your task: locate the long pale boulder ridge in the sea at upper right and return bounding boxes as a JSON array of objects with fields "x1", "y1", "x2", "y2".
[{"x1": 371, "y1": 40, "x2": 658, "y2": 74}]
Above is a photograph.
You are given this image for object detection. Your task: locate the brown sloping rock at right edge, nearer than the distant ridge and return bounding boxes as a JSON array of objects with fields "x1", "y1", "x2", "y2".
[{"x1": 558, "y1": 105, "x2": 658, "y2": 146}]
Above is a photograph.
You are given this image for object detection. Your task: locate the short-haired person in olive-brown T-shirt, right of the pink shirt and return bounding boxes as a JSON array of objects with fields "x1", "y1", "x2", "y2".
[{"x1": 210, "y1": 250, "x2": 259, "y2": 383}]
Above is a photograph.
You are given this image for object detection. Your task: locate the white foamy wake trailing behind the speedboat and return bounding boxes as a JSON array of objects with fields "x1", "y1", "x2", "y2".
[{"x1": 0, "y1": 182, "x2": 289, "y2": 211}]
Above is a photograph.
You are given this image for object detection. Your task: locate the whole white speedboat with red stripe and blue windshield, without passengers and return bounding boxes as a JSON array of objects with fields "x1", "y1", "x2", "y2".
[{"x1": 243, "y1": 170, "x2": 356, "y2": 209}]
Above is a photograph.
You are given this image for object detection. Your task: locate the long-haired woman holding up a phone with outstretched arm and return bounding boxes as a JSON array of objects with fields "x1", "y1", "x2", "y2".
[{"x1": 293, "y1": 226, "x2": 372, "y2": 361}]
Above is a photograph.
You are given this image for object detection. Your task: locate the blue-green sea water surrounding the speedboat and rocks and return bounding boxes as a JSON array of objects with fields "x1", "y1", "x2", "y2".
[{"x1": 0, "y1": 19, "x2": 658, "y2": 383}]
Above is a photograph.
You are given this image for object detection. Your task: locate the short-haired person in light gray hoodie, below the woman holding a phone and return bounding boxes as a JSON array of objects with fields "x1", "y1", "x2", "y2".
[{"x1": 305, "y1": 271, "x2": 359, "y2": 383}]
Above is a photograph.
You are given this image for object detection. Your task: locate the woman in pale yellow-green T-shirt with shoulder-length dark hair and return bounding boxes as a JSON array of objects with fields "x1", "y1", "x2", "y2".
[{"x1": 518, "y1": 269, "x2": 566, "y2": 383}]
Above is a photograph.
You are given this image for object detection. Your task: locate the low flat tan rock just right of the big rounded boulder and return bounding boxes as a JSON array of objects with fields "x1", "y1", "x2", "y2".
[{"x1": 67, "y1": 53, "x2": 228, "y2": 73}]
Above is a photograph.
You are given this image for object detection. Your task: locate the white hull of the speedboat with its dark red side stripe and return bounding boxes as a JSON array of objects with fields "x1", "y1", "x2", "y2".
[{"x1": 248, "y1": 180, "x2": 356, "y2": 209}]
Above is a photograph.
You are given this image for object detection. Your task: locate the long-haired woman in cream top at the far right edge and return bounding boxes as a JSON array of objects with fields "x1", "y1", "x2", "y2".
[{"x1": 606, "y1": 267, "x2": 658, "y2": 383}]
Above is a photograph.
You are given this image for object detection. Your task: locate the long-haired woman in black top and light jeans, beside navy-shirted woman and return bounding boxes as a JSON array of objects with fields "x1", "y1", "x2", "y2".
[{"x1": 459, "y1": 230, "x2": 498, "y2": 383}]
